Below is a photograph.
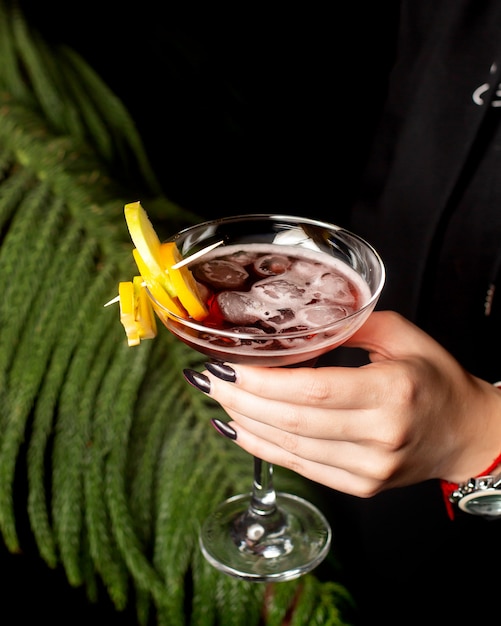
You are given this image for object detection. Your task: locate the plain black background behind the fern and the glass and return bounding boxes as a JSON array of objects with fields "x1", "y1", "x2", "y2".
[{"x1": 0, "y1": 0, "x2": 398, "y2": 626}]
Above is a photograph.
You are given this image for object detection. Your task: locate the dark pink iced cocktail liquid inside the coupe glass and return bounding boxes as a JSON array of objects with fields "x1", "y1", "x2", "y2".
[{"x1": 156, "y1": 243, "x2": 371, "y2": 366}]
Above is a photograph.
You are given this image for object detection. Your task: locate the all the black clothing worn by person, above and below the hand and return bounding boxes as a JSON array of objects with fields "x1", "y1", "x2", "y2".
[{"x1": 324, "y1": 0, "x2": 501, "y2": 626}]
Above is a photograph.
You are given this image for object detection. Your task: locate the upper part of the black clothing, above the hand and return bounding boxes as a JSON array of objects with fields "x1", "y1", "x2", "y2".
[{"x1": 353, "y1": 1, "x2": 501, "y2": 370}]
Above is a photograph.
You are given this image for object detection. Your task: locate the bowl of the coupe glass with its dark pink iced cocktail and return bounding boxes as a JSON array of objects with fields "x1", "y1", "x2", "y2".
[{"x1": 149, "y1": 216, "x2": 384, "y2": 367}]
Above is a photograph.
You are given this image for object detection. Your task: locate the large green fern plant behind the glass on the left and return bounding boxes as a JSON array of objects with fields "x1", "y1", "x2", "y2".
[{"x1": 0, "y1": 0, "x2": 356, "y2": 626}]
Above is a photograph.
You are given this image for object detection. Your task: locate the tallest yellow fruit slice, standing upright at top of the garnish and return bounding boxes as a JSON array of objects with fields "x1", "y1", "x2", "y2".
[{"x1": 124, "y1": 202, "x2": 176, "y2": 297}]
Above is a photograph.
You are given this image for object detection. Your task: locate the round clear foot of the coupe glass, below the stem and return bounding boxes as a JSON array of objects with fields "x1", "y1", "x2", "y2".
[{"x1": 200, "y1": 493, "x2": 331, "y2": 582}]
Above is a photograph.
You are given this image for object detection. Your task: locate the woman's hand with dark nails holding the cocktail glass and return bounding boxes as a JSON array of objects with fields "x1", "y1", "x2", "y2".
[{"x1": 189, "y1": 311, "x2": 501, "y2": 497}]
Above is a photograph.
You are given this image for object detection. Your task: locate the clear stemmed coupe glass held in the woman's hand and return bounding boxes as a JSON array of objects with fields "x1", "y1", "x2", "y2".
[{"x1": 149, "y1": 214, "x2": 385, "y2": 581}]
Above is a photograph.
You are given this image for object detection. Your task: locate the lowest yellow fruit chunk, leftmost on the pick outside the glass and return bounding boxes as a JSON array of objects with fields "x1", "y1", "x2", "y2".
[{"x1": 118, "y1": 276, "x2": 157, "y2": 346}]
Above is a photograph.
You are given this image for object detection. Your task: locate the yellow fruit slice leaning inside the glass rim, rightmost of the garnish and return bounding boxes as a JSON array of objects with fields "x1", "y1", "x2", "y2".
[{"x1": 159, "y1": 242, "x2": 208, "y2": 320}]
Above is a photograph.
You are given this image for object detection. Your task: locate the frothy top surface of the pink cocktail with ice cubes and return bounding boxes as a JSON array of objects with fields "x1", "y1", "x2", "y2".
[{"x1": 191, "y1": 244, "x2": 365, "y2": 335}]
